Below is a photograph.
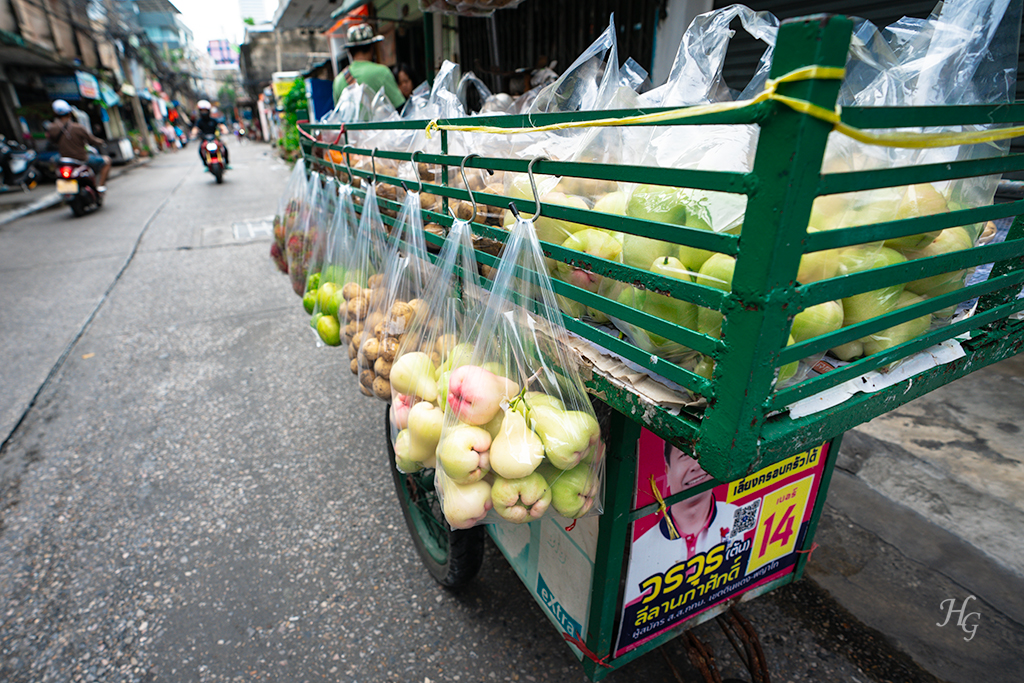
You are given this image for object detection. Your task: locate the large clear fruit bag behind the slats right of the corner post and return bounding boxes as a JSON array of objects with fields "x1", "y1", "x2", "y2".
[{"x1": 794, "y1": 0, "x2": 1015, "y2": 367}]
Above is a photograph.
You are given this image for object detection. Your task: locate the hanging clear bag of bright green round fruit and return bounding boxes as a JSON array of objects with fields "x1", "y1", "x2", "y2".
[{"x1": 302, "y1": 184, "x2": 358, "y2": 346}]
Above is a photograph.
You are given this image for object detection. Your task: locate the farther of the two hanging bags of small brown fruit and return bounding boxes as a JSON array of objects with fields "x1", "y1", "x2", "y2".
[{"x1": 338, "y1": 182, "x2": 387, "y2": 396}]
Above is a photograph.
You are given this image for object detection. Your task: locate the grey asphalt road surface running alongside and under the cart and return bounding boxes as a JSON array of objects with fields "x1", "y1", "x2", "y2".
[{"x1": 0, "y1": 143, "x2": 931, "y2": 683}]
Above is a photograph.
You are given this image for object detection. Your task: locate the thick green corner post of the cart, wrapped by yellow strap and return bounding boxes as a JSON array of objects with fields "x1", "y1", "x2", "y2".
[{"x1": 696, "y1": 16, "x2": 852, "y2": 481}]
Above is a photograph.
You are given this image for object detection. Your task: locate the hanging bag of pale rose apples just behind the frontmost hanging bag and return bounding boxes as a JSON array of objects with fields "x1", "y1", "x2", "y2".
[{"x1": 390, "y1": 220, "x2": 486, "y2": 473}]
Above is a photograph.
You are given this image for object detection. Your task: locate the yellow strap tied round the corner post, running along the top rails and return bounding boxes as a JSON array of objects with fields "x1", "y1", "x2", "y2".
[{"x1": 426, "y1": 67, "x2": 1024, "y2": 150}]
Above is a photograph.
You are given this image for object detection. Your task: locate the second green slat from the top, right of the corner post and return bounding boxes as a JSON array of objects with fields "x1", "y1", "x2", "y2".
[{"x1": 817, "y1": 155, "x2": 1024, "y2": 195}]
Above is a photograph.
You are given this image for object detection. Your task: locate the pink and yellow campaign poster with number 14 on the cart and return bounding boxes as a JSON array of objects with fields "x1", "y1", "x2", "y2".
[{"x1": 614, "y1": 429, "x2": 827, "y2": 656}]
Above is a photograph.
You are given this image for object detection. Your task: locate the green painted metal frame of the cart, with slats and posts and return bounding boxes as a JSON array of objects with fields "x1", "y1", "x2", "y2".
[{"x1": 303, "y1": 15, "x2": 1024, "y2": 680}]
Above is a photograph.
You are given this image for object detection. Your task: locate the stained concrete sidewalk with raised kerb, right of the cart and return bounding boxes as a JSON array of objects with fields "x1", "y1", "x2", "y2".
[{"x1": 807, "y1": 355, "x2": 1024, "y2": 683}]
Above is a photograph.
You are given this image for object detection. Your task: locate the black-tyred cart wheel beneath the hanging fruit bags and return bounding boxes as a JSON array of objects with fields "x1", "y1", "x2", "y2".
[{"x1": 384, "y1": 405, "x2": 484, "y2": 589}]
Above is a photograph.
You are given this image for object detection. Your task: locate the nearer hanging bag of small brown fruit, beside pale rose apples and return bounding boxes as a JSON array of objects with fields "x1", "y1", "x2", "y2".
[{"x1": 356, "y1": 185, "x2": 434, "y2": 402}]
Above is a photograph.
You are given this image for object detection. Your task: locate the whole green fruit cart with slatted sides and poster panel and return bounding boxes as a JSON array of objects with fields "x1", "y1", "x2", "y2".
[{"x1": 303, "y1": 15, "x2": 1024, "y2": 680}]
